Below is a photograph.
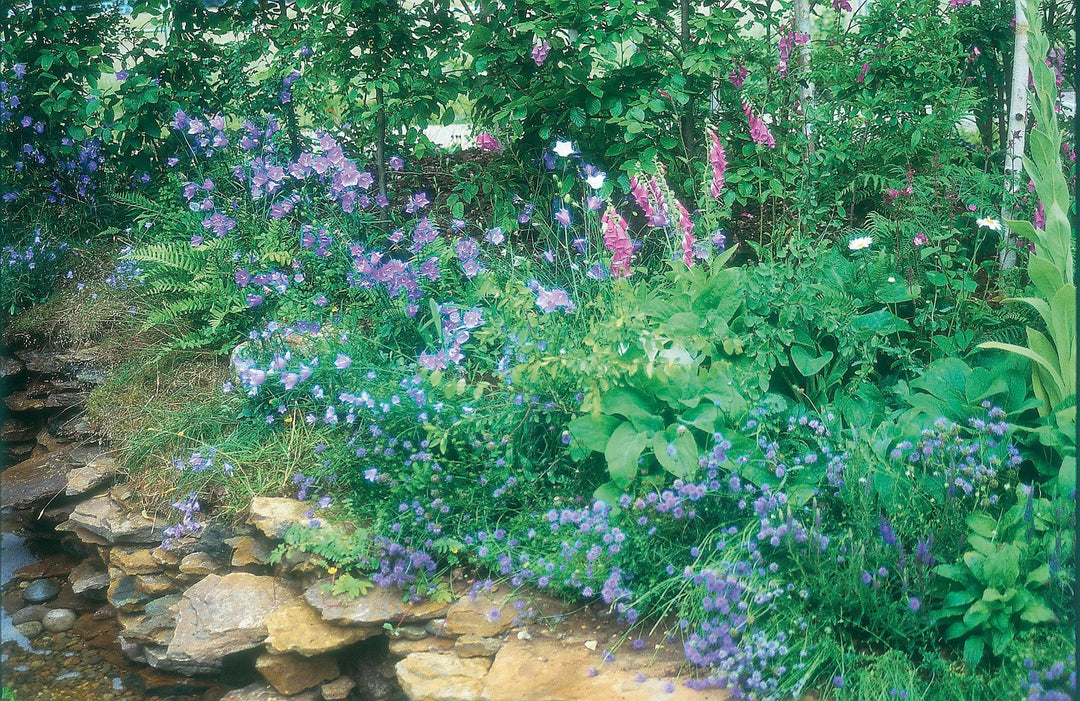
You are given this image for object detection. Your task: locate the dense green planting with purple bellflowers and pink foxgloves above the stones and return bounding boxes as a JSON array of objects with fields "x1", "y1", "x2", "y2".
[{"x1": 0, "y1": 0, "x2": 1077, "y2": 699}]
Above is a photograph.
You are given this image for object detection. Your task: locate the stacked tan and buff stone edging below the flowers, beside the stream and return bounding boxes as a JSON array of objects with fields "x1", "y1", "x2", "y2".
[{"x1": 42, "y1": 477, "x2": 730, "y2": 701}]
